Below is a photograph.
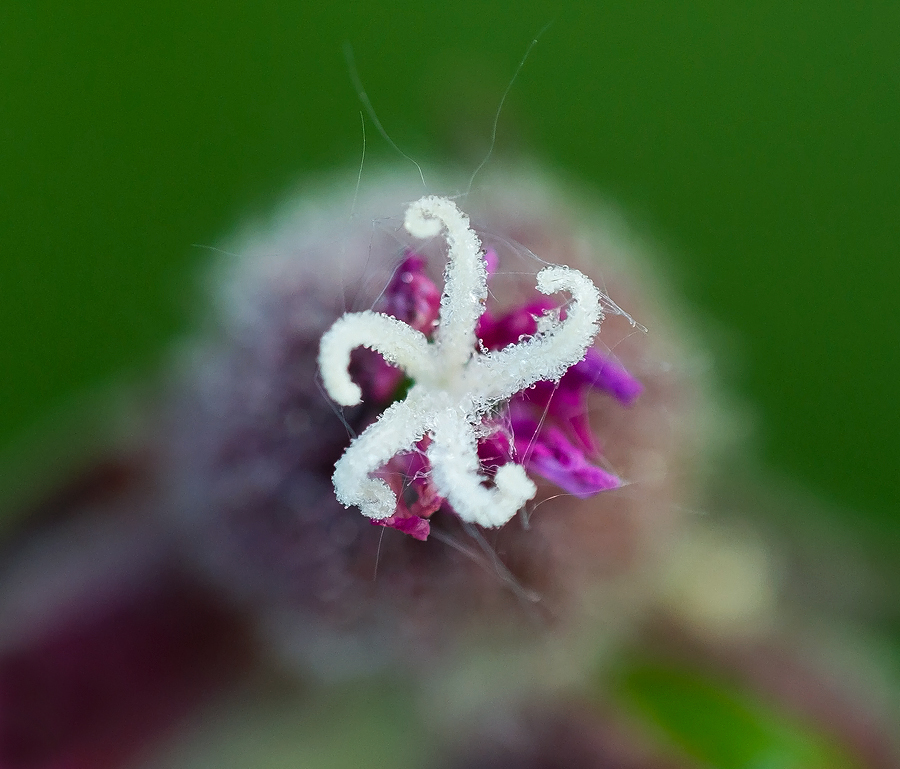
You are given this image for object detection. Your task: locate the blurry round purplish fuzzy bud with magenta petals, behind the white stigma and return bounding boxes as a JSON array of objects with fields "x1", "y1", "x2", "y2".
[{"x1": 167, "y1": 168, "x2": 697, "y2": 677}]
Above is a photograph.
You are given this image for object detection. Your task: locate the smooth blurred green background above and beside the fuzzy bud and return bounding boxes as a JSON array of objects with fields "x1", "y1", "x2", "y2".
[{"x1": 0, "y1": 0, "x2": 900, "y2": 534}]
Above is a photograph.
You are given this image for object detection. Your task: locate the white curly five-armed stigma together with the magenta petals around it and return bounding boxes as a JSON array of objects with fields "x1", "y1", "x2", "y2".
[{"x1": 319, "y1": 192, "x2": 641, "y2": 540}]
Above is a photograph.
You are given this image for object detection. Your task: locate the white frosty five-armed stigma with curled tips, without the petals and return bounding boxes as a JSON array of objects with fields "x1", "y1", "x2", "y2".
[{"x1": 319, "y1": 196, "x2": 603, "y2": 527}]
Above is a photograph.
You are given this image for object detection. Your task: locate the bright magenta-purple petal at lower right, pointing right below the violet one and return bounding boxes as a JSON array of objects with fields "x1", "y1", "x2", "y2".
[{"x1": 516, "y1": 426, "x2": 622, "y2": 499}]
